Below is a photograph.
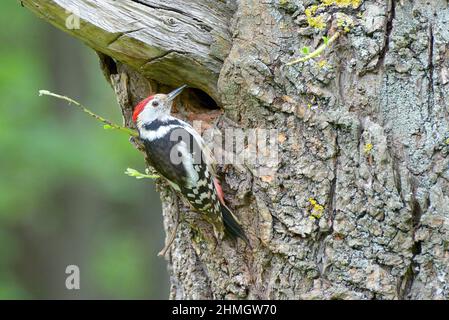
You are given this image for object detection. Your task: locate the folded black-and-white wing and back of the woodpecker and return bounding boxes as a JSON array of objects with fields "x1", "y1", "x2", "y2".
[{"x1": 140, "y1": 119, "x2": 224, "y2": 236}]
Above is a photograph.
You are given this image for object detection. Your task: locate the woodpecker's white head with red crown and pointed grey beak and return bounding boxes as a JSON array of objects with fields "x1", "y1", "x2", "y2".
[{"x1": 133, "y1": 85, "x2": 187, "y2": 130}]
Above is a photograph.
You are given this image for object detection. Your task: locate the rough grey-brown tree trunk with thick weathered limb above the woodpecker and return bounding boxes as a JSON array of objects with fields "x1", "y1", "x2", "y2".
[{"x1": 23, "y1": 0, "x2": 449, "y2": 299}]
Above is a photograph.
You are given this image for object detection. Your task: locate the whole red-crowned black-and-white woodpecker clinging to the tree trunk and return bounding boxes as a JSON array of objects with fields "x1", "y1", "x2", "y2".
[{"x1": 133, "y1": 85, "x2": 249, "y2": 244}]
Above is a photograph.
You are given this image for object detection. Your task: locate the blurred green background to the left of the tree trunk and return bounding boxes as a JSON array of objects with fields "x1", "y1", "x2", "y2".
[{"x1": 0, "y1": 1, "x2": 168, "y2": 299}]
